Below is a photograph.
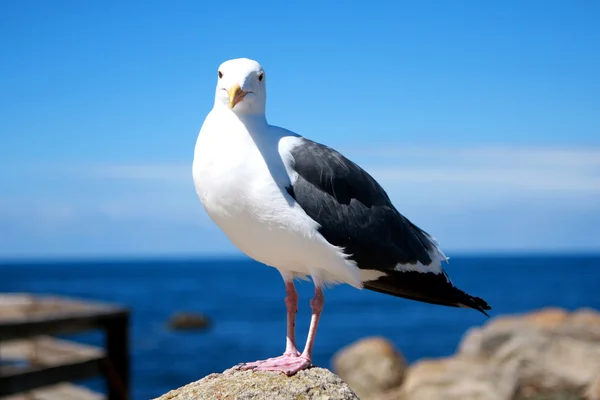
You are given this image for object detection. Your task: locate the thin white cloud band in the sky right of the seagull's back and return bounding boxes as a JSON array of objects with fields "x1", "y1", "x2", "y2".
[{"x1": 346, "y1": 147, "x2": 600, "y2": 193}]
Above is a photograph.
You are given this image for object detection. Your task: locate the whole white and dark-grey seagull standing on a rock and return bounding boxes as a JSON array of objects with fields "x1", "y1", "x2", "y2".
[{"x1": 192, "y1": 58, "x2": 491, "y2": 376}]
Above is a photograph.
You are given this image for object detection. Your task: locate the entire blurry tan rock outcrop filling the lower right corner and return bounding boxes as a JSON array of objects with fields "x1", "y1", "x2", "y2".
[{"x1": 390, "y1": 308, "x2": 600, "y2": 400}]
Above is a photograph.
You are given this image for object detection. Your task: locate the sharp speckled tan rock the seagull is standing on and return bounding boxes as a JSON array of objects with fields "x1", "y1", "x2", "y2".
[{"x1": 156, "y1": 367, "x2": 358, "y2": 400}]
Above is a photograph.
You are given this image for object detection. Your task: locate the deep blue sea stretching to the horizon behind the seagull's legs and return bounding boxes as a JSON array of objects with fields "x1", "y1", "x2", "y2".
[{"x1": 0, "y1": 255, "x2": 600, "y2": 400}]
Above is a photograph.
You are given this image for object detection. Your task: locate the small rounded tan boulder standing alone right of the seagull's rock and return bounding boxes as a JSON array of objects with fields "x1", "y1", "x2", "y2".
[{"x1": 333, "y1": 337, "x2": 406, "y2": 400}]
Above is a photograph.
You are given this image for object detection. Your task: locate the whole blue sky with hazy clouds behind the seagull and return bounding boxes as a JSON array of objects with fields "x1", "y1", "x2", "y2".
[{"x1": 0, "y1": 0, "x2": 600, "y2": 258}]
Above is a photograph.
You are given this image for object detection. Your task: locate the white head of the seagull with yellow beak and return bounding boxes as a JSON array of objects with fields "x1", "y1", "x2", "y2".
[{"x1": 215, "y1": 58, "x2": 267, "y2": 116}]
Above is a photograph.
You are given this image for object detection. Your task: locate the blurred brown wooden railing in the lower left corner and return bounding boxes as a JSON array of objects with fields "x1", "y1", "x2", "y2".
[{"x1": 0, "y1": 294, "x2": 130, "y2": 400}]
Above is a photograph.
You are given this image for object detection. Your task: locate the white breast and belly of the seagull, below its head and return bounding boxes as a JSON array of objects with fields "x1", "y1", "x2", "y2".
[{"x1": 193, "y1": 111, "x2": 361, "y2": 287}]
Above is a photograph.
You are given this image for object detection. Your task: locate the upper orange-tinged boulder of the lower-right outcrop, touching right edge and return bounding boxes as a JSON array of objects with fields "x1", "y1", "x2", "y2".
[{"x1": 458, "y1": 309, "x2": 600, "y2": 399}]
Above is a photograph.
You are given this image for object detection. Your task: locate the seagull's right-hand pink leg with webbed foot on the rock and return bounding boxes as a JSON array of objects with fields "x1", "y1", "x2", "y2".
[{"x1": 245, "y1": 287, "x2": 325, "y2": 376}]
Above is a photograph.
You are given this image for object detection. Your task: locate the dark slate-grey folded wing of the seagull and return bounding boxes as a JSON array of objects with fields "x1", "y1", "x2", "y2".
[{"x1": 287, "y1": 138, "x2": 435, "y2": 270}]
